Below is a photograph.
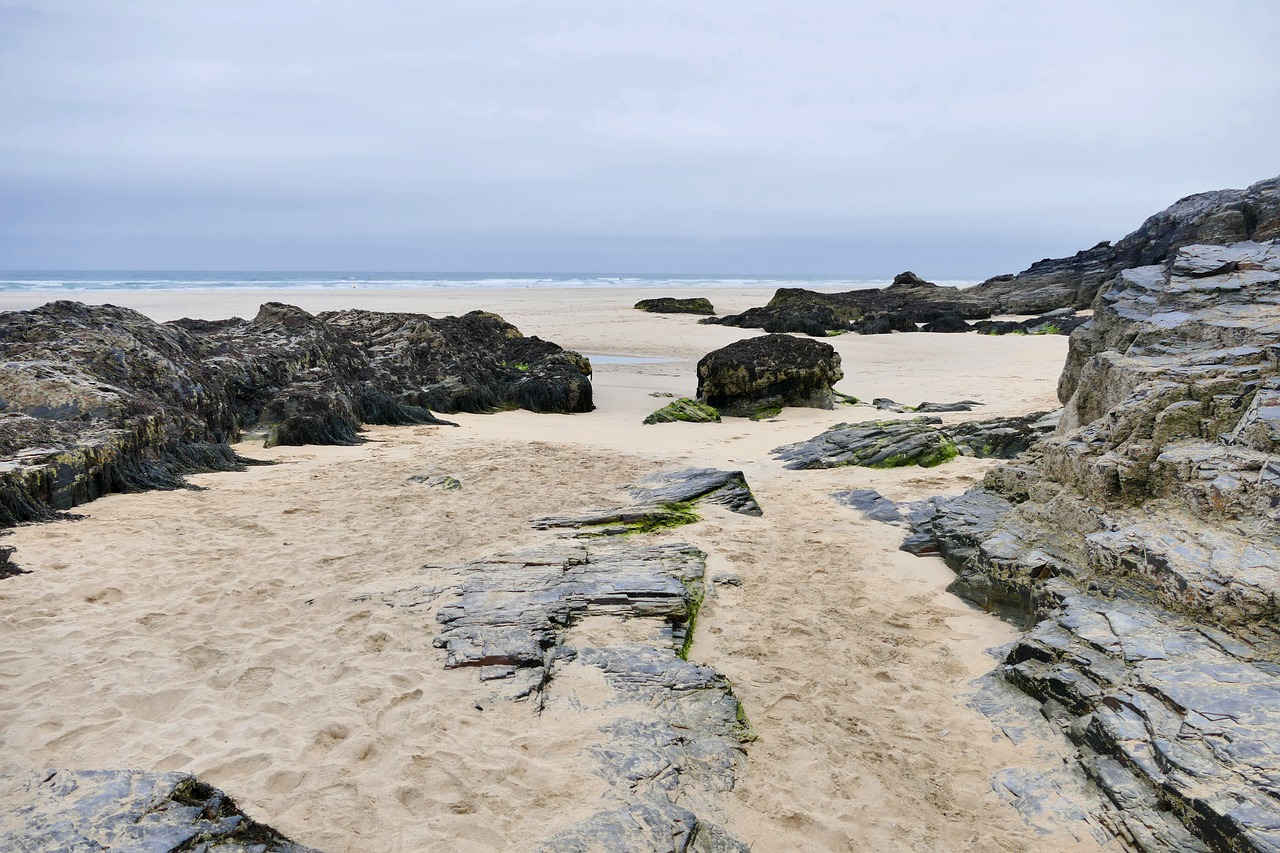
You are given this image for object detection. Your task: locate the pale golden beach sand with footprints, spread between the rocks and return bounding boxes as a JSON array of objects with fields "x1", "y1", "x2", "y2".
[{"x1": 0, "y1": 289, "x2": 1098, "y2": 853}]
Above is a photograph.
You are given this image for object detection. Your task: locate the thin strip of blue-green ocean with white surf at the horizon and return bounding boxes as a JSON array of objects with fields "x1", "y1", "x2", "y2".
[{"x1": 0, "y1": 270, "x2": 975, "y2": 293}]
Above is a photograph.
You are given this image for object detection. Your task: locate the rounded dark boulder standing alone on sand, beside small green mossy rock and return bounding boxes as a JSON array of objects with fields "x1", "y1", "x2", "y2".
[{"x1": 698, "y1": 334, "x2": 845, "y2": 418}]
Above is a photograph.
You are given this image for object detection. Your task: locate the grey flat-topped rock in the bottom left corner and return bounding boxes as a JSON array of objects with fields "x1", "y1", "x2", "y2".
[{"x1": 0, "y1": 770, "x2": 316, "y2": 853}]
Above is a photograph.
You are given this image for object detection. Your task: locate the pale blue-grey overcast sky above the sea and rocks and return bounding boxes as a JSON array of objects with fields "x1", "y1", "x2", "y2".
[{"x1": 0, "y1": 0, "x2": 1280, "y2": 279}]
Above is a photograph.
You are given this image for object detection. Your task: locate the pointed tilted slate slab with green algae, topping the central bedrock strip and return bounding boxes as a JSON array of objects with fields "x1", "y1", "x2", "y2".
[{"x1": 532, "y1": 467, "x2": 764, "y2": 537}]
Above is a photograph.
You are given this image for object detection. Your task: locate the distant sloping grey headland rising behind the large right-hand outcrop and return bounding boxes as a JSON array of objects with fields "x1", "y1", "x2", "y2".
[{"x1": 970, "y1": 177, "x2": 1280, "y2": 314}]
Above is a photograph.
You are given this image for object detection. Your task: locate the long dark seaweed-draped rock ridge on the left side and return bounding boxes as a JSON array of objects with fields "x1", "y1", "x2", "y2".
[{"x1": 0, "y1": 301, "x2": 591, "y2": 526}]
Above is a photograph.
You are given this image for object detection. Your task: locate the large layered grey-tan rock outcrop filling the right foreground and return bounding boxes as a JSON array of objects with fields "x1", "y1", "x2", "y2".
[{"x1": 846, "y1": 241, "x2": 1280, "y2": 853}]
